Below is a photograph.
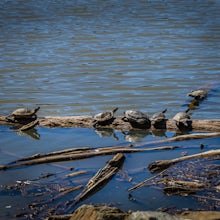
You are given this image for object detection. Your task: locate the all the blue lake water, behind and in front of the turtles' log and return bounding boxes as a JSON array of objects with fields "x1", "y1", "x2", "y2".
[{"x1": 0, "y1": 0, "x2": 220, "y2": 218}]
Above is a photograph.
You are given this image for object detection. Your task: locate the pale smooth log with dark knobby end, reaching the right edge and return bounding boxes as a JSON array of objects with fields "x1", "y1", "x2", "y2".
[{"x1": 148, "y1": 150, "x2": 220, "y2": 173}]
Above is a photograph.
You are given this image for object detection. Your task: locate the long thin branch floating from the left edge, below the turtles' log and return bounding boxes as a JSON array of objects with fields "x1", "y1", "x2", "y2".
[{"x1": 0, "y1": 146, "x2": 177, "y2": 170}]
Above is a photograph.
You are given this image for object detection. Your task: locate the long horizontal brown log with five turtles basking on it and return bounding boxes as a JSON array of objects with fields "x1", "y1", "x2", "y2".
[{"x1": 0, "y1": 115, "x2": 220, "y2": 132}]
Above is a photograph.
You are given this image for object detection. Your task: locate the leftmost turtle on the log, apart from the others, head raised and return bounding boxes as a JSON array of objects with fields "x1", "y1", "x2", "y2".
[{"x1": 6, "y1": 106, "x2": 40, "y2": 122}]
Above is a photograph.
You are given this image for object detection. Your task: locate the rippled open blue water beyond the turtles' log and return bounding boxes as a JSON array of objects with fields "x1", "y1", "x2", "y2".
[{"x1": 0, "y1": 0, "x2": 220, "y2": 119}]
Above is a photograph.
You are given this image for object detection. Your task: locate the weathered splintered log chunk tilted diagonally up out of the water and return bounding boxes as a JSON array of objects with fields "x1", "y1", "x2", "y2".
[{"x1": 71, "y1": 153, "x2": 125, "y2": 205}]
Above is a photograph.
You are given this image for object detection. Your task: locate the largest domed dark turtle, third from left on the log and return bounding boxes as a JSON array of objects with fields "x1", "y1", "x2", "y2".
[{"x1": 122, "y1": 110, "x2": 151, "y2": 127}]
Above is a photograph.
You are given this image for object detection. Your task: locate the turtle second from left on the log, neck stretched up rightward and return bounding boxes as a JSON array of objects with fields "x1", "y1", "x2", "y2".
[{"x1": 93, "y1": 108, "x2": 118, "y2": 127}]
